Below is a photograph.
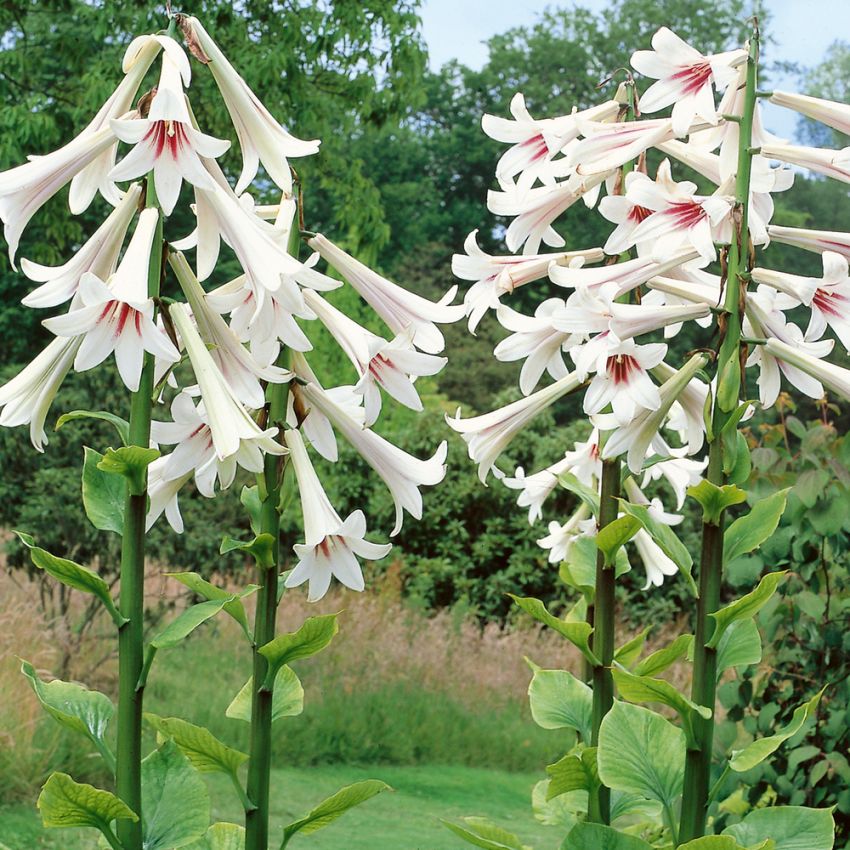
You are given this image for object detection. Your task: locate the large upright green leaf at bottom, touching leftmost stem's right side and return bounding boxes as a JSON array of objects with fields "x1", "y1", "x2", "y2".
[{"x1": 142, "y1": 741, "x2": 210, "y2": 850}]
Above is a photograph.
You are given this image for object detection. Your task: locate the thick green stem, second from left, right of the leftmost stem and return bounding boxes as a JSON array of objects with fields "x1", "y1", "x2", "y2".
[{"x1": 245, "y1": 376, "x2": 287, "y2": 850}]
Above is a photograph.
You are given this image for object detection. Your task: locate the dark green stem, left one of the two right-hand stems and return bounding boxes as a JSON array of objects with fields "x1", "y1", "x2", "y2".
[{"x1": 588, "y1": 460, "x2": 620, "y2": 823}]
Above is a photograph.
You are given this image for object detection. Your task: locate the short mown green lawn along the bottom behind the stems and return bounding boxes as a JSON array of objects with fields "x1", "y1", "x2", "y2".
[{"x1": 0, "y1": 766, "x2": 563, "y2": 850}]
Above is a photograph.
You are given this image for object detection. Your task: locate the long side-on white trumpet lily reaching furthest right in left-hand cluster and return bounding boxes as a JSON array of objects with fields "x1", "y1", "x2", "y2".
[{"x1": 307, "y1": 233, "x2": 466, "y2": 354}]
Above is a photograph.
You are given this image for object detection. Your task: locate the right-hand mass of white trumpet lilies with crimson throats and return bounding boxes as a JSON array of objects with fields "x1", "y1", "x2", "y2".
[{"x1": 449, "y1": 28, "x2": 850, "y2": 586}]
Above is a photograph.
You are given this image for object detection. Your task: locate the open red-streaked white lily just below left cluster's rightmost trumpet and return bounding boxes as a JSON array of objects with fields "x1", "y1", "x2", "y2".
[{"x1": 304, "y1": 290, "x2": 448, "y2": 426}]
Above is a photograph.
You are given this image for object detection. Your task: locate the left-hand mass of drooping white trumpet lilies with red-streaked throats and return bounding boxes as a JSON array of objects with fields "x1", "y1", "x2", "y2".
[{"x1": 0, "y1": 16, "x2": 465, "y2": 599}]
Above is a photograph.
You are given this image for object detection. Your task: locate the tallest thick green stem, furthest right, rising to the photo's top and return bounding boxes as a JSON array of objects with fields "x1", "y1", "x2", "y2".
[{"x1": 679, "y1": 32, "x2": 759, "y2": 843}]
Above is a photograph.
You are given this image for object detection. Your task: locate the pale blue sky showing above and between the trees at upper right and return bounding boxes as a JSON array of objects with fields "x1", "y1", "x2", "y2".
[{"x1": 421, "y1": 0, "x2": 850, "y2": 138}]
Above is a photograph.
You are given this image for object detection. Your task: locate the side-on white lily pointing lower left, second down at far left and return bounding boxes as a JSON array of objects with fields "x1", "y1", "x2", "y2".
[{"x1": 21, "y1": 183, "x2": 142, "y2": 307}]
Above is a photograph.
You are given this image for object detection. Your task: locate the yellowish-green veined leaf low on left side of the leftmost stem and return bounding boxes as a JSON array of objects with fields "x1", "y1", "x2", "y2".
[{"x1": 36, "y1": 773, "x2": 139, "y2": 835}]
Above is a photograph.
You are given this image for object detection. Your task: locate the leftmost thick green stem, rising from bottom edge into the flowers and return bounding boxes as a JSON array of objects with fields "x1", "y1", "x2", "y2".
[{"x1": 115, "y1": 175, "x2": 163, "y2": 850}]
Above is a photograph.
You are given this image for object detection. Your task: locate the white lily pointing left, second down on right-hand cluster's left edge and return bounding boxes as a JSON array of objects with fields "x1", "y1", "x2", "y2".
[{"x1": 487, "y1": 171, "x2": 608, "y2": 254}]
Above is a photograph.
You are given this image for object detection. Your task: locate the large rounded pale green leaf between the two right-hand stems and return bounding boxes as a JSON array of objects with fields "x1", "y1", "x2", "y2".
[{"x1": 597, "y1": 700, "x2": 685, "y2": 808}]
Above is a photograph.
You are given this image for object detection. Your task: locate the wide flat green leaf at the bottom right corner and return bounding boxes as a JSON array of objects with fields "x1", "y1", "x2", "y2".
[{"x1": 723, "y1": 806, "x2": 835, "y2": 850}]
